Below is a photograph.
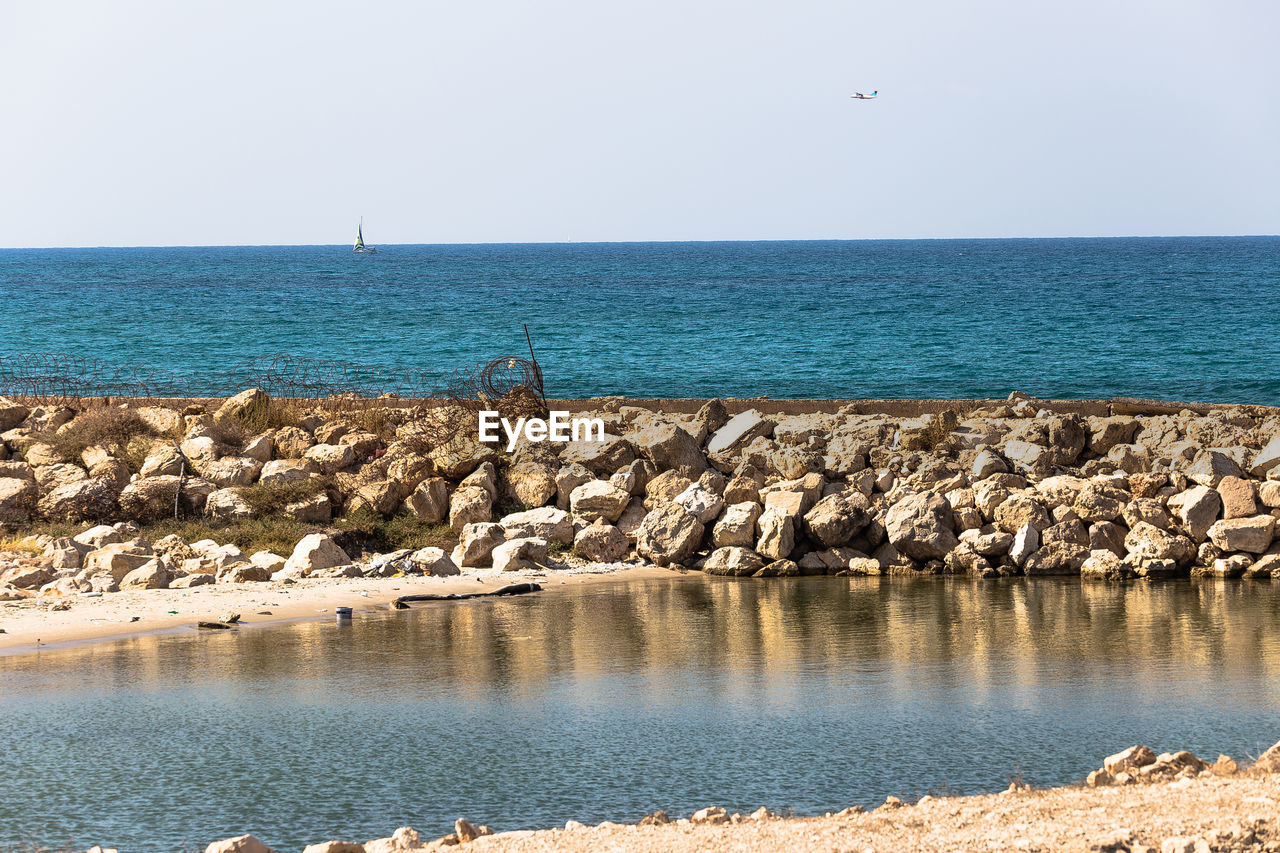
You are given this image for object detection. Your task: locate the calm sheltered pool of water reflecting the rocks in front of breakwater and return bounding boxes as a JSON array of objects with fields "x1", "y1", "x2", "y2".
[{"x1": 0, "y1": 575, "x2": 1280, "y2": 850}]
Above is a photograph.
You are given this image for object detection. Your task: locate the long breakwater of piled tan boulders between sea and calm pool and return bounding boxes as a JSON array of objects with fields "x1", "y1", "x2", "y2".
[{"x1": 0, "y1": 389, "x2": 1280, "y2": 594}]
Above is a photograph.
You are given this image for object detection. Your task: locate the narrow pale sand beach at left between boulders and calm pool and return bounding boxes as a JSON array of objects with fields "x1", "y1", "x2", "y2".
[{"x1": 0, "y1": 565, "x2": 673, "y2": 654}]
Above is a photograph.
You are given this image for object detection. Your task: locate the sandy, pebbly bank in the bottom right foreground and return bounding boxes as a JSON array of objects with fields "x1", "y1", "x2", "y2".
[{"x1": 442, "y1": 774, "x2": 1280, "y2": 853}]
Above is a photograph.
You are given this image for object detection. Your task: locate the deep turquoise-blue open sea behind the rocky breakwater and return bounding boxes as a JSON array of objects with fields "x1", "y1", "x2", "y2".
[{"x1": 0, "y1": 237, "x2": 1280, "y2": 405}]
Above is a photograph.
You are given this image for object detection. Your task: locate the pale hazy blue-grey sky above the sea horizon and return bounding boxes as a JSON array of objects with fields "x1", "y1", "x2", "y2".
[{"x1": 0, "y1": 0, "x2": 1280, "y2": 247}]
